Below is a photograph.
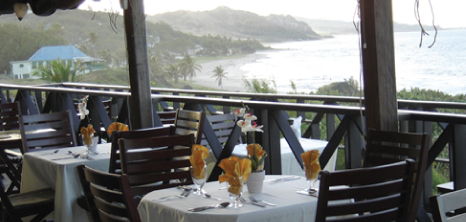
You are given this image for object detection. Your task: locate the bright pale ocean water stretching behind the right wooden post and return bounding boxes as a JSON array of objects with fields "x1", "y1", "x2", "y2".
[{"x1": 241, "y1": 29, "x2": 466, "y2": 95}]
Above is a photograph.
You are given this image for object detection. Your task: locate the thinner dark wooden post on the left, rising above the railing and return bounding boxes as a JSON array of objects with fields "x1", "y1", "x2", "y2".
[{"x1": 124, "y1": 0, "x2": 154, "y2": 129}]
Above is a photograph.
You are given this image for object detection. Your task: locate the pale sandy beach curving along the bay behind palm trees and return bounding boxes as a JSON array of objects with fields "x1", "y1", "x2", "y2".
[{"x1": 193, "y1": 53, "x2": 266, "y2": 92}]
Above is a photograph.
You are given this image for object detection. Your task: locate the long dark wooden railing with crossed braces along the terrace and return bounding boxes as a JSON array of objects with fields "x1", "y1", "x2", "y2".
[{"x1": 0, "y1": 83, "x2": 466, "y2": 201}]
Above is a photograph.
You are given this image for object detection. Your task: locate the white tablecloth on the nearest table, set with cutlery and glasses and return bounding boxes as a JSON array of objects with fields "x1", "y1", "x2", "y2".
[{"x1": 138, "y1": 175, "x2": 317, "y2": 222}]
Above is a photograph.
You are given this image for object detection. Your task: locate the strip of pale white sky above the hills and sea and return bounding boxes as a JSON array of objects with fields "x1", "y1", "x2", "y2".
[{"x1": 80, "y1": 0, "x2": 466, "y2": 28}]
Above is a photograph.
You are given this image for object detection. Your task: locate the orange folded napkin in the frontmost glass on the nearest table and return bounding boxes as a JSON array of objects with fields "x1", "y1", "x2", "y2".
[{"x1": 218, "y1": 156, "x2": 251, "y2": 195}]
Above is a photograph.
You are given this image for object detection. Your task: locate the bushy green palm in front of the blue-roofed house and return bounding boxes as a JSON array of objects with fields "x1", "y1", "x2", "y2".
[{"x1": 32, "y1": 58, "x2": 84, "y2": 83}]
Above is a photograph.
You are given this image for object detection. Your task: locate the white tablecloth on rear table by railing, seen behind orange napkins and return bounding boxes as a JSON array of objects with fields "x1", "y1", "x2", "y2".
[{"x1": 233, "y1": 138, "x2": 337, "y2": 176}]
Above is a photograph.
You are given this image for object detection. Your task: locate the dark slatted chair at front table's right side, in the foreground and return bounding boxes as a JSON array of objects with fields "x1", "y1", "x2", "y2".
[{"x1": 315, "y1": 160, "x2": 414, "y2": 222}]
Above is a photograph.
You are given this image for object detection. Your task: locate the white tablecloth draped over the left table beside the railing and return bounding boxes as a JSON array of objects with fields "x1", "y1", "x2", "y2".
[{"x1": 21, "y1": 143, "x2": 111, "y2": 222}]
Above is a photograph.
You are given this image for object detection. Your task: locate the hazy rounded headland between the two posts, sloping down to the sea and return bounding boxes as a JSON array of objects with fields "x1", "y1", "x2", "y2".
[{"x1": 147, "y1": 6, "x2": 322, "y2": 41}]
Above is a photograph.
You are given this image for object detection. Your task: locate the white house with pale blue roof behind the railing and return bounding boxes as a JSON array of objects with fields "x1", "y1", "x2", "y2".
[{"x1": 10, "y1": 45, "x2": 106, "y2": 79}]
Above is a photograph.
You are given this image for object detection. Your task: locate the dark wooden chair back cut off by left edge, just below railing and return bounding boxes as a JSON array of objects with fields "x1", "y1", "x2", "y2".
[{"x1": 0, "y1": 102, "x2": 21, "y2": 131}]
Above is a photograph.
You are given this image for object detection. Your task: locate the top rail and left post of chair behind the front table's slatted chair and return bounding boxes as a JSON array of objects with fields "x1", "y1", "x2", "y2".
[{"x1": 108, "y1": 126, "x2": 175, "y2": 174}]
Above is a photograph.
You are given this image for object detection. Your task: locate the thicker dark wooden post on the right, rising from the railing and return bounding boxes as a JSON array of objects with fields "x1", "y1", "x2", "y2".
[{"x1": 360, "y1": 0, "x2": 398, "y2": 131}]
